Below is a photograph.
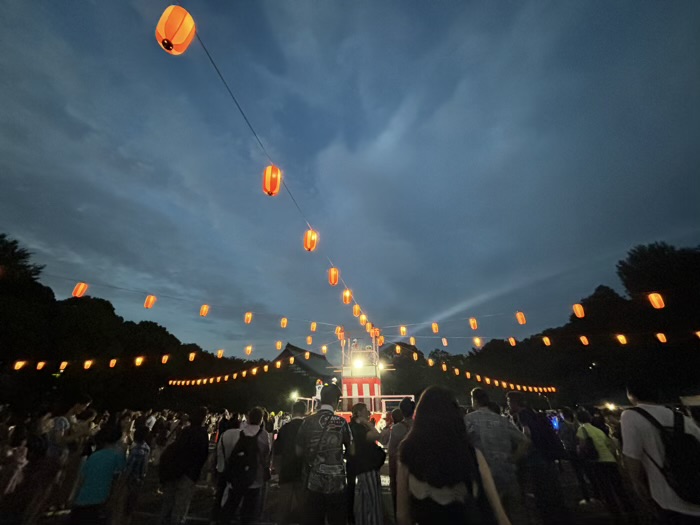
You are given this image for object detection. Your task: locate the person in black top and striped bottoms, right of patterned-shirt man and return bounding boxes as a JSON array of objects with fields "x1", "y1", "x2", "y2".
[{"x1": 347, "y1": 403, "x2": 386, "y2": 525}]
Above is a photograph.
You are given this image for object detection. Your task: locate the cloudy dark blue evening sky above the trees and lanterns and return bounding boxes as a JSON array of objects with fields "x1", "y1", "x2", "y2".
[{"x1": 0, "y1": 0, "x2": 700, "y2": 357}]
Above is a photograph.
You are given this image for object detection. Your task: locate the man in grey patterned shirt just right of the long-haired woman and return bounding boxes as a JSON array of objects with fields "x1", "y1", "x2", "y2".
[{"x1": 464, "y1": 388, "x2": 529, "y2": 524}]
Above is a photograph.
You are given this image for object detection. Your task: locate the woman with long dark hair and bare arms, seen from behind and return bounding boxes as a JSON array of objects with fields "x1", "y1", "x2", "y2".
[{"x1": 397, "y1": 386, "x2": 510, "y2": 525}]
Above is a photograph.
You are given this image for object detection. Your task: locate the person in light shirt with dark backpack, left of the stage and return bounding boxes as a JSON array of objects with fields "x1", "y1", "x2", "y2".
[{"x1": 214, "y1": 407, "x2": 270, "y2": 525}]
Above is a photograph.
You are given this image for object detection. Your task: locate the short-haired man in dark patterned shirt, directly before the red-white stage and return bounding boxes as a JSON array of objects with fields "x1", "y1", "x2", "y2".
[{"x1": 296, "y1": 384, "x2": 354, "y2": 525}]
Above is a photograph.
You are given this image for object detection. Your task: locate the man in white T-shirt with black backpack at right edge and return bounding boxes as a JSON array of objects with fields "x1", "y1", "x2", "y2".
[{"x1": 620, "y1": 374, "x2": 700, "y2": 525}]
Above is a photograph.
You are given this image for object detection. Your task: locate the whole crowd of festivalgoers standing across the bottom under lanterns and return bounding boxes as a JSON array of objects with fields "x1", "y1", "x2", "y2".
[{"x1": 0, "y1": 370, "x2": 700, "y2": 525}]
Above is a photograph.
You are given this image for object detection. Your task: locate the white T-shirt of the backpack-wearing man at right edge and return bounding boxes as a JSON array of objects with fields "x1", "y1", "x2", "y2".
[{"x1": 620, "y1": 403, "x2": 700, "y2": 516}]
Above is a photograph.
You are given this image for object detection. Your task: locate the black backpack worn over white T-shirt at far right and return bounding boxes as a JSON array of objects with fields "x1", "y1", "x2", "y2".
[{"x1": 630, "y1": 407, "x2": 700, "y2": 505}]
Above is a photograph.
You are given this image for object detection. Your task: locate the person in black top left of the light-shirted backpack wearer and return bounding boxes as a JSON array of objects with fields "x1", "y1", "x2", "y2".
[{"x1": 160, "y1": 407, "x2": 209, "y2": 525}]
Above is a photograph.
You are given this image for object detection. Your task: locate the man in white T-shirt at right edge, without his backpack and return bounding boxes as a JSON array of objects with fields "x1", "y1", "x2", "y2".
[{"x1": 620, "y1": 375, "x2": 700, "y2": 525}]
